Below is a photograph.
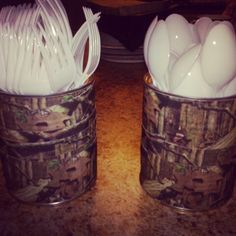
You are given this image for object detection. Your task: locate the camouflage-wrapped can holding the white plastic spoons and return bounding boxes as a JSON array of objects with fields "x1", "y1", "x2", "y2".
[{"x1": 140, "y1": 75, "x2": 236, "y2": 211}]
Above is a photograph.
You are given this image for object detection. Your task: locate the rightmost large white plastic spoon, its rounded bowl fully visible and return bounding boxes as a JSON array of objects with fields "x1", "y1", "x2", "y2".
[{"x1": 200, "y1": 23, "x2": 236, "y2": 90}]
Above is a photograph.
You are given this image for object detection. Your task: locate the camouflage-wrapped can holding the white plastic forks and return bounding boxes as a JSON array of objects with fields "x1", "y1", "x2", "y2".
[{"x1": 0, "y1": 82, "x2": 97, "y2": 205}]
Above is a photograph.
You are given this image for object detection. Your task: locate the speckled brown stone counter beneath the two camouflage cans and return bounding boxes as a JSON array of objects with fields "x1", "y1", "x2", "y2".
[{"x1": 0, "y1": 62, "x2": 236, "y2": 236}]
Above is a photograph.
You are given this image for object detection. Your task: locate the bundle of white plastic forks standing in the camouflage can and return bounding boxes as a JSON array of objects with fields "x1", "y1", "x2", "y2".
[{"x1": 0, "y1": 0, "x2": 101, "y2": 95}]
